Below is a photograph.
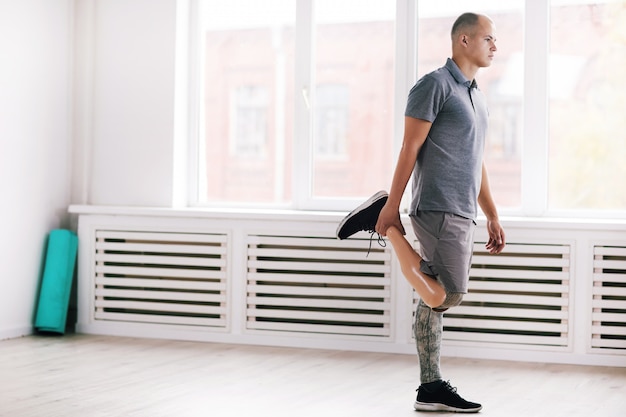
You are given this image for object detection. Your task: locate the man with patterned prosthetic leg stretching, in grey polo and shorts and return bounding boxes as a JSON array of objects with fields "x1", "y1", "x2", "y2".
[{"x1": 338, "y1": 13, "x2": 505, "y2": 412}]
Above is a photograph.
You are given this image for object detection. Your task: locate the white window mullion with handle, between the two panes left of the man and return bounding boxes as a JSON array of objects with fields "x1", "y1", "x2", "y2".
[{"x1": 293, "y1": 0, "x2": 315, "y2": 209}]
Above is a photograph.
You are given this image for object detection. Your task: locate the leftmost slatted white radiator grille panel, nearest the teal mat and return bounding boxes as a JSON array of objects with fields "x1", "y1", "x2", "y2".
[{"x1": 93, "y1": 230, "x2": 228, "y2": 328}]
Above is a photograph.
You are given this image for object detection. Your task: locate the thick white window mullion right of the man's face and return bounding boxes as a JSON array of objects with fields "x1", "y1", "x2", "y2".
[{"x1": 520, "y1": 0, "x2": 550, "y2": 216}]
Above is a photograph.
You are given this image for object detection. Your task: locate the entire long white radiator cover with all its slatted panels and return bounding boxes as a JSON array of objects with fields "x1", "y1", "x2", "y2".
[{"x1": 70, "y1": 208, "x2": 626, "y2": 366}]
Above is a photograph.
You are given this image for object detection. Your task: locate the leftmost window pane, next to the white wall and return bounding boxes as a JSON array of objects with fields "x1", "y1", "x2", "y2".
[{"x1": 196, "y1": 0, "x2": 295, "y2": 206}]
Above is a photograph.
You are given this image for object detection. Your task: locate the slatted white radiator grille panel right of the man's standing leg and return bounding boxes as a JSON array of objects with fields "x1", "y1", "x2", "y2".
[{"x1": 434, "y1": 242, "x2": 571, "y2": 350}]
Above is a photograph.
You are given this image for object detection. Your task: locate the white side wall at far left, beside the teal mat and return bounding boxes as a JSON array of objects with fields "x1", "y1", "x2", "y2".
[{"x1": 0, "y1": 0, "x2": 72, "y2": 339}]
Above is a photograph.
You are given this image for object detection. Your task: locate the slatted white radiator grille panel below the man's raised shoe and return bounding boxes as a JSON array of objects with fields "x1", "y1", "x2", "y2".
[{"x1": 246, "y1": 235, "x2": 392, "y2": 338}]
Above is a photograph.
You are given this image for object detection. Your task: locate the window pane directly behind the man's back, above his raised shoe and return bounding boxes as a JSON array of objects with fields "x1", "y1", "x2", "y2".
[{"x1": 302, "y1": 0, "x2": 395, "y2": 204}]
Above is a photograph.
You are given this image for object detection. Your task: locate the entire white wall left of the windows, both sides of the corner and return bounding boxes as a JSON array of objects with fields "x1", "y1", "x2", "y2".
[{"x1": 0, "y1": 0, "x2": 184, "y2": 339}]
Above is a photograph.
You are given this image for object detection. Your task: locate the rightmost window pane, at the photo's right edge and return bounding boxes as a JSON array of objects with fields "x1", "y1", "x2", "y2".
[{"x1": 548, "y1": 1, "x2": 626, "y2": 210}]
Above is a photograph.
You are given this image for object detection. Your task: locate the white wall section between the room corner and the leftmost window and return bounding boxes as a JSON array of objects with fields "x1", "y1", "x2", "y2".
[{"x1": 73, "y1": 0, "x2": 178, "y2": 207}]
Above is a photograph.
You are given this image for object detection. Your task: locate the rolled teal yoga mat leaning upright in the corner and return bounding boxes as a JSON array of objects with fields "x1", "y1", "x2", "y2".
[{"x1": 35, "y1": 229, "x2": 78, "y2": 334}]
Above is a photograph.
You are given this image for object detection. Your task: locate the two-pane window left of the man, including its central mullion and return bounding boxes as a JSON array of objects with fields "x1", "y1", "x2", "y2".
[{"x1": 196, "y1": 0, "x2": 395, "y2": 208}]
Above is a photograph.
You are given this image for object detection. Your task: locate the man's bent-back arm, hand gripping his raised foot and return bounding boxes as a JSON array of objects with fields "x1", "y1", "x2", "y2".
[{"x1": 376, "y1": 116, "x2": 432, "y2": 236}]
